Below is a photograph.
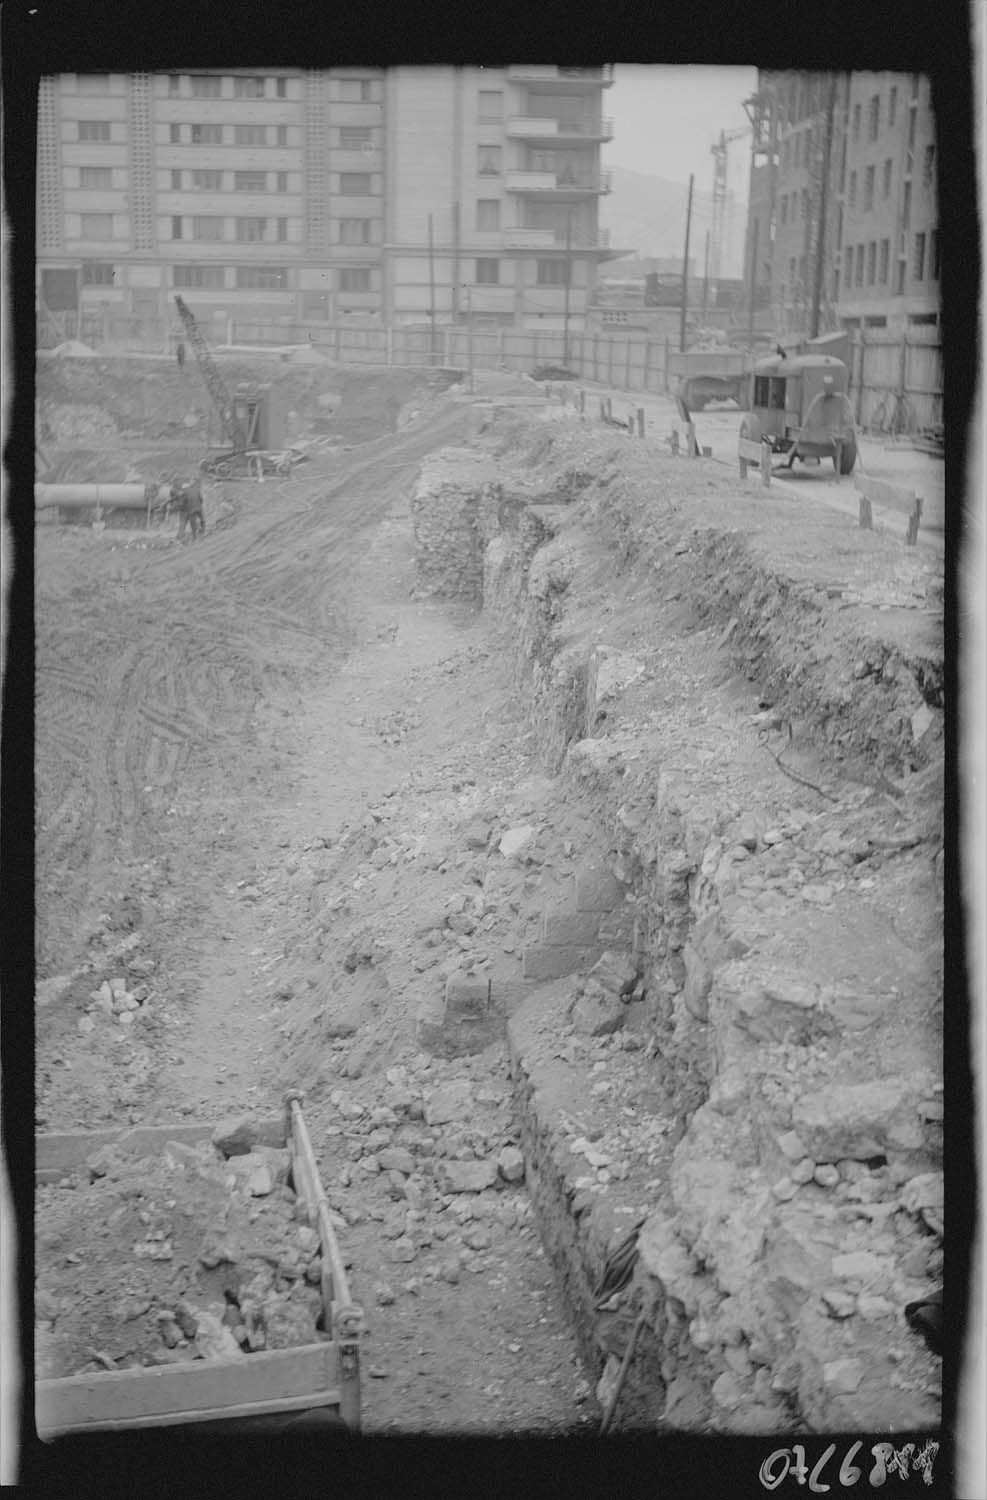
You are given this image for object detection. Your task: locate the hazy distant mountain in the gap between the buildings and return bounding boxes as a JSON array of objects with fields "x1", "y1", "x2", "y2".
[{"x1": 600, "y1": 167, "x2": 747, "y2": 278}]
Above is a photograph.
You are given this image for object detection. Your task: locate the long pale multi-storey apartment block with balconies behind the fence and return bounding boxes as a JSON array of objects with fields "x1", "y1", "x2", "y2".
[{"x1": 38, "y1": 65, "x2": 618, "y2": 330}]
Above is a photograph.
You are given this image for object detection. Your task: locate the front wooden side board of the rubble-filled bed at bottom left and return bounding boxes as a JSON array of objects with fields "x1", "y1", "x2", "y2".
[{"x1": 35, "y1": 1341, "x2": 339, "y2": 1437}]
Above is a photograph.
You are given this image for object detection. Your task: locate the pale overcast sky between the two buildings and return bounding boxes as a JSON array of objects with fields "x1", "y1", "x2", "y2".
[{"x1": 603, "y1": 63, "x2": 758, "y2": 201}]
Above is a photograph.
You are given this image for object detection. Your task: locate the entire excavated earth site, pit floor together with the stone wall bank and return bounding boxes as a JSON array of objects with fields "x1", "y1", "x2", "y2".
[{"x1": 39, "y1": 372, "x2": 942, "y2": 1433}]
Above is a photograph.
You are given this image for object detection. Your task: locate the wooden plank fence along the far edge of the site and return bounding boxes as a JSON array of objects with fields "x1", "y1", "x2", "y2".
[{"x1": 38, "y1": 312, "x2": 944, "y2": 434}]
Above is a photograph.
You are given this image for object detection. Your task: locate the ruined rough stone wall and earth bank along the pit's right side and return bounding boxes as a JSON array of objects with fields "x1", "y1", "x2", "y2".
[{"x1": 414, "y1": 425, "x2": 944, "y2": 1433}]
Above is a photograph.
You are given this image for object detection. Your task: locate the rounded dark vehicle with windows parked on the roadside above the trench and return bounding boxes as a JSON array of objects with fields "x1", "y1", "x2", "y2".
[{"x1": 738, "y1": 354, "x2": 857, "y2": 476}]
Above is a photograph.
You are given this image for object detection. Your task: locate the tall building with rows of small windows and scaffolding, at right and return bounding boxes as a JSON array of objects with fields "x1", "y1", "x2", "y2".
[{"x1": 746, "y1": 72, "x2": 939, "y2": 333}]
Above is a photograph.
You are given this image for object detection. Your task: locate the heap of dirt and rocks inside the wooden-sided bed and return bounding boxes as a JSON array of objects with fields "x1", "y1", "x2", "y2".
[{"x1": 35, "y1": 1142, "x2": 321, "y2": 1379}]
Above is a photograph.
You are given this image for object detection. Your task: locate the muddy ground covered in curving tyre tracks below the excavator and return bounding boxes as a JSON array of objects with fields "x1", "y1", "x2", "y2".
[{"x1": 38, "y1": 408, "x2": 467, "y2": 962}]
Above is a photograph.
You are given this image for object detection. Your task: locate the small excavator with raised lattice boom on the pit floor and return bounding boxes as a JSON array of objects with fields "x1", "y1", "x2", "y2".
[{"x1": 174, "y1": 293, "x2": 306, "y2": 479}]
